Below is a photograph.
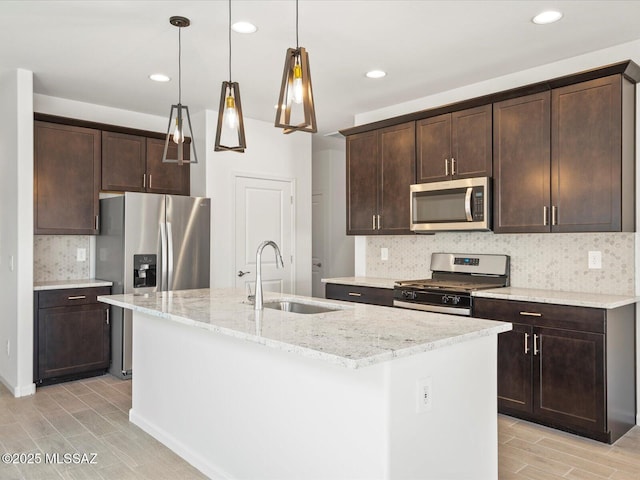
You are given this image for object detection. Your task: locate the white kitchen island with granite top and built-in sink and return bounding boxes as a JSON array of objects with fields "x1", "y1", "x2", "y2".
[{"x1": 99, "y1": 289, "x2": 511, "y2": 479}]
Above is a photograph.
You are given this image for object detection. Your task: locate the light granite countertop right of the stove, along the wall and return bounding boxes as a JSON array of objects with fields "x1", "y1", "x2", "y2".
[{"x1": 472, "y1": 287, "x2": 640, "y2": 309}]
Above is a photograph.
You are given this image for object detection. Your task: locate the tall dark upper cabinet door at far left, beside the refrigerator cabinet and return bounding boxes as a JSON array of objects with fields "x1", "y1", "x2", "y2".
[{"x1": 34, "y1": 121, "x2": 101, "y2": 235}]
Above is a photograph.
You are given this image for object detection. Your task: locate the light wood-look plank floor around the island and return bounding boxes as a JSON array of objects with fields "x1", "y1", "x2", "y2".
[{"x1": 0, "y1": 375, "x2": 640, "y2": 480}]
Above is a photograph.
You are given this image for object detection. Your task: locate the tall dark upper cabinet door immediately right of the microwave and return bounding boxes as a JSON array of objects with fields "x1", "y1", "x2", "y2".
[{"x1": 493, "y1": 92, "x2": 551, "y2": 233}]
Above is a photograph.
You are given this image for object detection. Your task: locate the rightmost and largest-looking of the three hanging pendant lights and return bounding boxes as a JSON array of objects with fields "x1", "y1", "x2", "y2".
[{"x1": 275, "y1": 0, "x2": 318, "y2": 133}]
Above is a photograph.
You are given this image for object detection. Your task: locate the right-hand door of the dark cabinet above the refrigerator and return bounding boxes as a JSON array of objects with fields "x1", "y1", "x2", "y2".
[{"x1": 147, "y1": 138, "x2": 191, "y2": 195}]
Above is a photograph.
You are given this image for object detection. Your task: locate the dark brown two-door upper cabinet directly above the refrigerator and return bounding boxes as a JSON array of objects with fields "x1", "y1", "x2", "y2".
[{"x1": 102, "y1": 131, "x2": 190, "y2": 195}]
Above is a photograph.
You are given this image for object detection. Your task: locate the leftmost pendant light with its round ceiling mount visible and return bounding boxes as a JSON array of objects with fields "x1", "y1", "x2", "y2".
[{"x1": 162, "y1": 16, "x2": 198, "y2": 165}]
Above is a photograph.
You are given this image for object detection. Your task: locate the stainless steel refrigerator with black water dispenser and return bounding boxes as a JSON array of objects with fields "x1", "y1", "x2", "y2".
[{"x1": 96, "y1": 192, "x2": 211, "y2": 378}]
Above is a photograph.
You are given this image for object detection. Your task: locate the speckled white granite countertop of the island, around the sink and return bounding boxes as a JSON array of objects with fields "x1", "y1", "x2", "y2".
[{"x1": 98, "y1": 288, "x2": 511, "y2": 368}]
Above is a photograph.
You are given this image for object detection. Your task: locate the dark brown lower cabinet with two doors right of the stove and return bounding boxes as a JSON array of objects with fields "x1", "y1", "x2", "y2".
[{"x1": 474, "y1": 298, "x2": 636, "y2": 443}]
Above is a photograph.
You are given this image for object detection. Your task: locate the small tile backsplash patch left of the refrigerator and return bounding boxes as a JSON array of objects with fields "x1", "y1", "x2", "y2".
[{"x1": 33, "y1": 235, "x2": 91, "y2": 282}]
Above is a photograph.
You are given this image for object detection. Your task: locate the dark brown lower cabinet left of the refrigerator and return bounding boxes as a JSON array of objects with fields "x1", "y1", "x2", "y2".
[{"x1": 33, "y1": 287, "x2": 111, "y2": 385}]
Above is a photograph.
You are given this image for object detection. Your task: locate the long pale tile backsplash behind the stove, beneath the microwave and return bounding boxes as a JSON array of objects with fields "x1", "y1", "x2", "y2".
[{"x1": 366, "y1": 232, "x2": 635, "y2": 295}]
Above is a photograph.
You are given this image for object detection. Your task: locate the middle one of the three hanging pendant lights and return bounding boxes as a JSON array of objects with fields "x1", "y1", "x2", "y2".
[{"x1": 214, "y1": 0, "x2": 247, "y2": 153}]
